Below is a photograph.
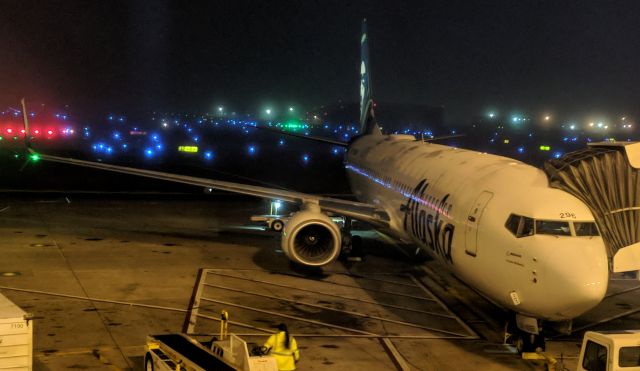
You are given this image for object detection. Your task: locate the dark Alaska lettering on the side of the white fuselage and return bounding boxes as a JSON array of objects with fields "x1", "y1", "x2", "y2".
[{"x1": 400, "y1": 179, "x2": 455, "y2": 264}]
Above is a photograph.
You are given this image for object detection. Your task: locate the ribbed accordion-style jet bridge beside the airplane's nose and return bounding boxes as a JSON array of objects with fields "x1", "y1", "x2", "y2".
[{"x1": 544, "y1": 142, "x2": 640, "y2": 272}]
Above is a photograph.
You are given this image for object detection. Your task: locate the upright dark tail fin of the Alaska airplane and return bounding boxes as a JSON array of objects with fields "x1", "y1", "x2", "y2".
[{"x1": 360, "y1": 19, "x2": 380, "y2": 134}]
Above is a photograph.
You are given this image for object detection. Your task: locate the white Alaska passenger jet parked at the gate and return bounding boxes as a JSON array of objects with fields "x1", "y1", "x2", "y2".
[{"x1": 22, "y1": 20, "x2": 620, "y2": 351}]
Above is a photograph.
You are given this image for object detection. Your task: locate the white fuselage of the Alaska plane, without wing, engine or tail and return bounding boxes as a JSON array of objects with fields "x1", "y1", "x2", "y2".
[{"x1": 345, "y1": 135, "x2": 608, "y2": 321}]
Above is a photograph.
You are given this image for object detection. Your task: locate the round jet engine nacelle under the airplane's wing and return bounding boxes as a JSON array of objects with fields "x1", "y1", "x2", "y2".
[{"x1": 282, "y1": 210, "x2": 342, "y2": 267}]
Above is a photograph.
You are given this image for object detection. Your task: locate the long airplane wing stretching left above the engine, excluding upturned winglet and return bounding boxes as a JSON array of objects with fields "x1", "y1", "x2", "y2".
[{"x1": 29, "y1": 152, "x2": 389, "y2": 227}]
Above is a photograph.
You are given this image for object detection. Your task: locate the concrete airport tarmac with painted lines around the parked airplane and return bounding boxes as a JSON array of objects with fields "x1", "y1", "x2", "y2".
[{"x1": 0, "y1": 193, "x2": 640, "y2": 370}]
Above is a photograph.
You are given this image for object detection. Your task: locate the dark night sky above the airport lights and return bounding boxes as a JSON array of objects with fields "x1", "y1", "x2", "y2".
[{"x1": 0, "y1": 0, "x2": 640, "y2": 122}]
